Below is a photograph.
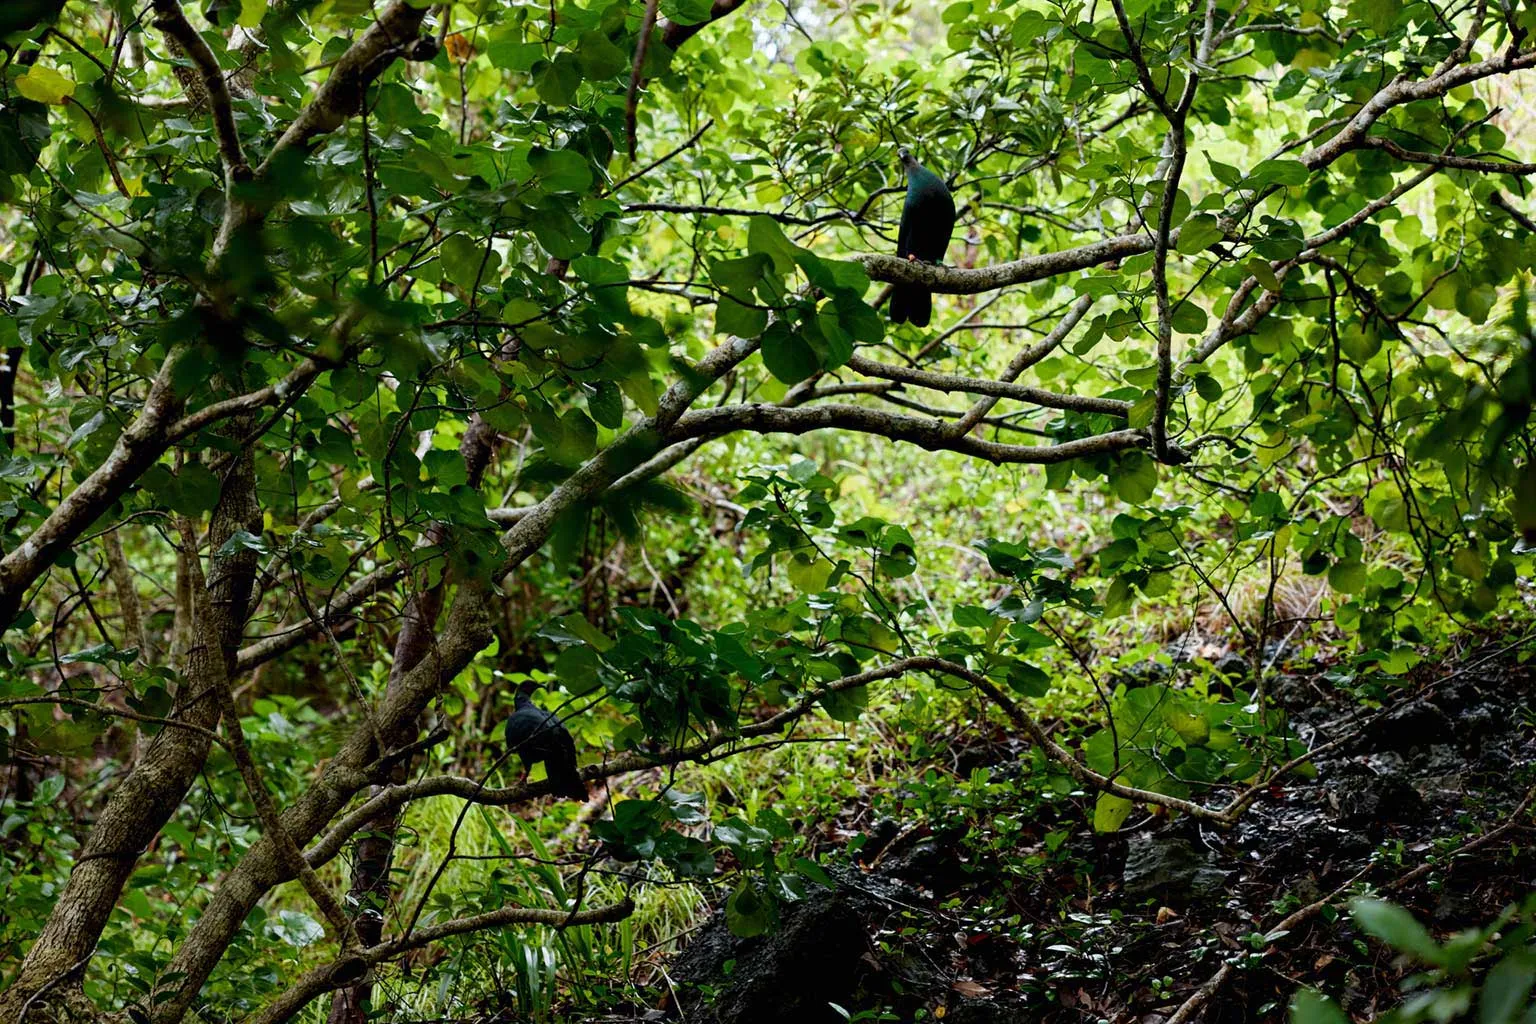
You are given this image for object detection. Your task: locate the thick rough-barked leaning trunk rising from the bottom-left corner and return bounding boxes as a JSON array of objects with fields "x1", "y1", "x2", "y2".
[{"x1": 0, "y1": 418, "x2": 261, "y2": 1024}]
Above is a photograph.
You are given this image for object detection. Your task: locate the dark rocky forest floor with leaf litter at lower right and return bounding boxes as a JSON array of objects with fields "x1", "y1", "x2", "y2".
[{"x1": 642, "y1": 640, "x2": 1536, "y2": 1024}]
